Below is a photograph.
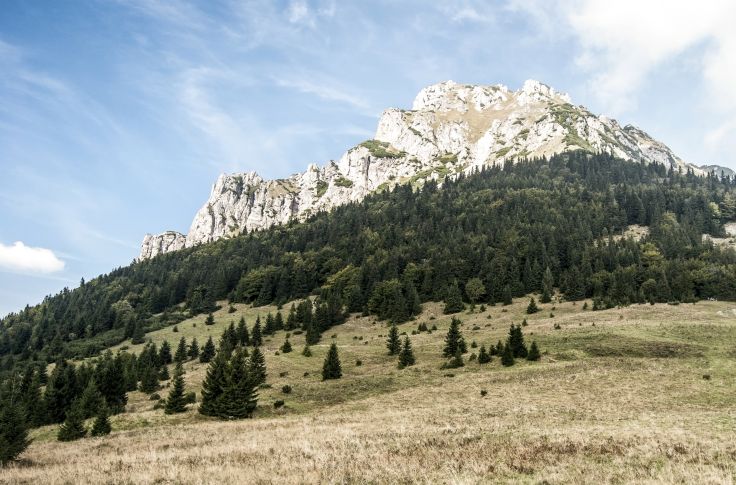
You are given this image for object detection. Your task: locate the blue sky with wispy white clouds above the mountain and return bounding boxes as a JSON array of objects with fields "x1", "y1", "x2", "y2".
[{"x1": 0, "y1": 0, "x2": 736, "y2": 315}]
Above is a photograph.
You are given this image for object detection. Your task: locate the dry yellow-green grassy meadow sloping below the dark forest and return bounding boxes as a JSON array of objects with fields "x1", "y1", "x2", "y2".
[{"x1": 0, "y1": 299, "x2": 736, "y2": 484}]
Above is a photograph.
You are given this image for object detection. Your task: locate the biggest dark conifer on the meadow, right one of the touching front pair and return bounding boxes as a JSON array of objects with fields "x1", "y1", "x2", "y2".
[{"x1": 218, "y1": 348, "x2": 258, "y2": 419}]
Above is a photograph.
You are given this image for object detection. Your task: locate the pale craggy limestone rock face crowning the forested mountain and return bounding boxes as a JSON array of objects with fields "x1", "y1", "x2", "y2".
[{"x1": 140, "y1": 81, "x2": 704, "y2": 259}]
